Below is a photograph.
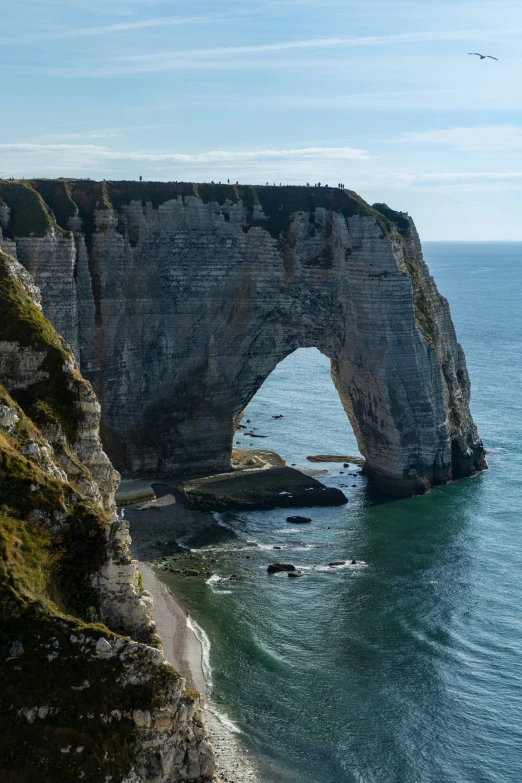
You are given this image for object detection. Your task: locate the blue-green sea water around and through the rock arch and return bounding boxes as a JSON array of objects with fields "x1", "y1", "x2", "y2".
[{"x1": 160, "y1": 243, "x2": 522, "y2": 783}]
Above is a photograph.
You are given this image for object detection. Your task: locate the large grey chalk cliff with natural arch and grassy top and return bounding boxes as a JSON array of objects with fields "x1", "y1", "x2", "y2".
[{"x1": 0, "y1": 180, "x2": 485, "y2": 495}]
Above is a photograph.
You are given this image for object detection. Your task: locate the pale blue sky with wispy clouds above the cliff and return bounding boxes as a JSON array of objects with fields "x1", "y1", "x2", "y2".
[{"x1": 0, "y1": 0, "x2": 522, "y2": 240}]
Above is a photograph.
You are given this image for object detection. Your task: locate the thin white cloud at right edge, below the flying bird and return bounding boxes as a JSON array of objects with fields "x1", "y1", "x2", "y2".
[{"x1": 395, "y1": 125, "x2": 522, "y2": 152}]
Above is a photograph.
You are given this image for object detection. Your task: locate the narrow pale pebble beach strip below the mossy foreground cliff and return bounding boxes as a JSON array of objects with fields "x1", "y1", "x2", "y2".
[{"x1": 139, "y1": 560, "x2": 261, "y2": 783}]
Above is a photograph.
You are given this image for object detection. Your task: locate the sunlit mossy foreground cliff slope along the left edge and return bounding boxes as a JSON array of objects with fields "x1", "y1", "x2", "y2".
[{"x1": 0, "y1": 252, "x2": 214, "y2": 783}]
